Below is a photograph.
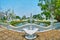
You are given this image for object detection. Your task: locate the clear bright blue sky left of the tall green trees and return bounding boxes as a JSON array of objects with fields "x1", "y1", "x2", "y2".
[{"x1": 0, "y1": 0, "x2": 41, "y2": 17}]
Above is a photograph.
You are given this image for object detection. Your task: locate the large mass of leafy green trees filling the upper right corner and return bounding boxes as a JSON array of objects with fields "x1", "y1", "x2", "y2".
[{"x1": 38, "y1": 0, "x2": 60, "y2": 21}]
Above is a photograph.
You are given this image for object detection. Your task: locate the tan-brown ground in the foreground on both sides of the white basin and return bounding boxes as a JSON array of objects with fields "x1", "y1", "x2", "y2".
[{"x1": 0, "y1": 29, "x2": 60, "y2": 40}]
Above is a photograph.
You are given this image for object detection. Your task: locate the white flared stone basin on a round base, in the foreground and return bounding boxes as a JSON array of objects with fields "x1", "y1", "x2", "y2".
[{"x1": 23, "y1": 28, "x2": 38, "y2": 40}]
